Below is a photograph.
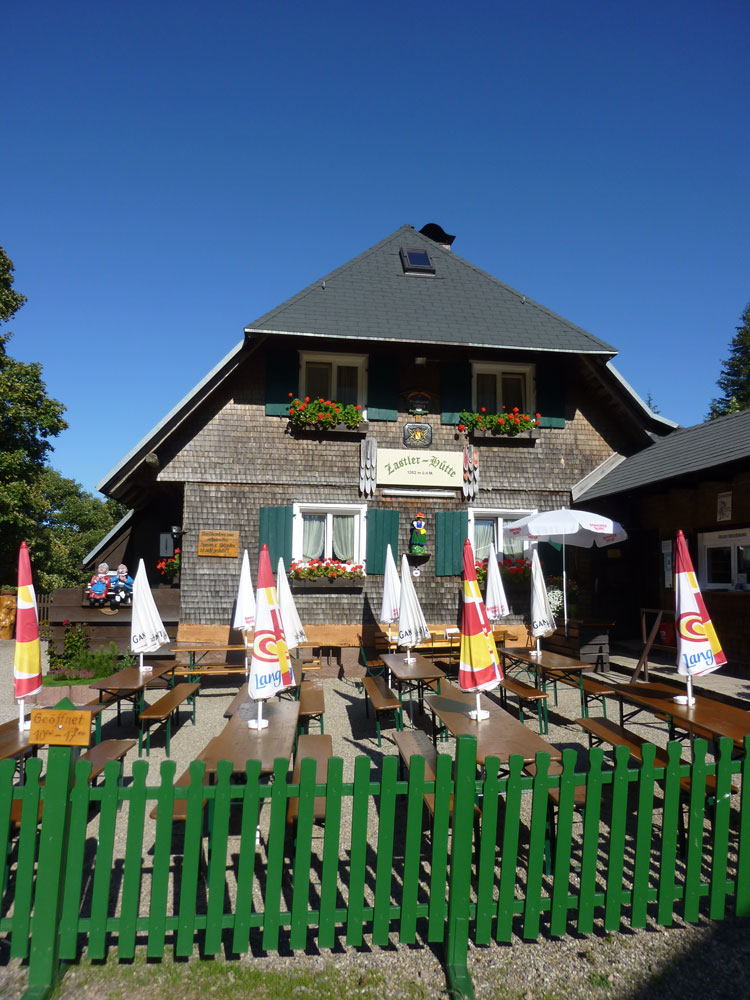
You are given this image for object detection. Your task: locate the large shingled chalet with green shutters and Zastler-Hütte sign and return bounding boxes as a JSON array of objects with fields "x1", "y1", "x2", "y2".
[{"x1": 90, "y1": 224, "x2": 675, "y2": 625}]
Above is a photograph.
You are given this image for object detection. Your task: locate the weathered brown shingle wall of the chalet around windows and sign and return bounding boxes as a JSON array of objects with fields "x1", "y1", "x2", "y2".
[{"x1": 163, "y1": 344, "x2": 624, "y2": 623}]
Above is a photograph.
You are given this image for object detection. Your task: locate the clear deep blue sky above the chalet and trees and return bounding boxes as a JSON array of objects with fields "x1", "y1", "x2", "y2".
[{"x1": 0, "y1": 0, "x2": 750, "y2": 491}]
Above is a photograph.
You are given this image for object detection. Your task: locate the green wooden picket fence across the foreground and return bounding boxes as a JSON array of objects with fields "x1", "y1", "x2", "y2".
[{"x1": 0, "y1": 737, "x2": 750, "y2": 997}]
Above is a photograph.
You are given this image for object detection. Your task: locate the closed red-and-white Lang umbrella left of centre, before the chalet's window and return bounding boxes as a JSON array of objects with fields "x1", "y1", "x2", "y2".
[{"x1": 247, "y1": 545, "x2": 294, "y2": 729}]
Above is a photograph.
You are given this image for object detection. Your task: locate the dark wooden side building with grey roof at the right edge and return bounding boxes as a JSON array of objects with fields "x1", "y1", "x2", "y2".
[{"x1": 573, "y1": 410, "x2": 750, "y2": 673}]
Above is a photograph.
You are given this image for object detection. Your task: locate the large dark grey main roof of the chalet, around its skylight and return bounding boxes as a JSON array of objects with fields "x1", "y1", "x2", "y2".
[{"x1": 246, "y1": 226, "x2": 617, "y2": 357}]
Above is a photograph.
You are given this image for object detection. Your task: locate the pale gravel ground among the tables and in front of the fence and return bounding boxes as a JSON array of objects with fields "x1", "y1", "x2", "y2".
[{"x1": 0, "y1": 643, "x2": 750, "y2": 1000}]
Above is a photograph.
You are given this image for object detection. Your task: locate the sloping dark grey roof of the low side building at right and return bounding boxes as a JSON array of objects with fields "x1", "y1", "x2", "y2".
[{"x1": 576, "y1": 410, "x2": 750, "y2": 503}]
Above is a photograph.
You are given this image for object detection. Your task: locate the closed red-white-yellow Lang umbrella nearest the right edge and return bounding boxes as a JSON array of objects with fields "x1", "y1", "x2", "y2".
[{"x1": 674, "y1": 531, "x2": 727, "y2": 705}]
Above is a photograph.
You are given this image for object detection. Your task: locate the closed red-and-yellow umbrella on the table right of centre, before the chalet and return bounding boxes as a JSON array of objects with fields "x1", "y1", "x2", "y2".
[{"x1": 458, "y1": 538, "x2": 503, "y2": 721}]
